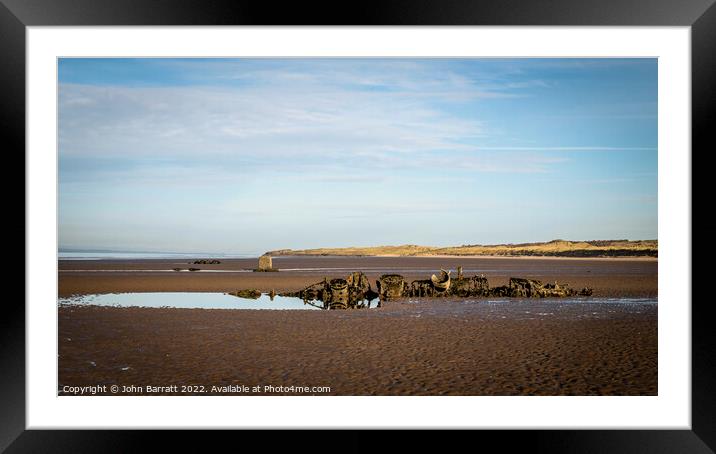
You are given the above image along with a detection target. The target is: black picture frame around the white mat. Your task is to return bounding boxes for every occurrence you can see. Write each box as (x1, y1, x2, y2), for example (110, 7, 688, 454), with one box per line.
(0, 0, 704, 453)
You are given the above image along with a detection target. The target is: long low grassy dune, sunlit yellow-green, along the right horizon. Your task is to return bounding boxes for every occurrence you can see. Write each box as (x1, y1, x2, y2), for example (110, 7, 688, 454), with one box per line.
(269, 240, 659, 257)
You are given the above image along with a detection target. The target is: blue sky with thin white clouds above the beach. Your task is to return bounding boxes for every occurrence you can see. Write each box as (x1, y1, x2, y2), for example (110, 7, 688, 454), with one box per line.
(58, 58, 658, 254)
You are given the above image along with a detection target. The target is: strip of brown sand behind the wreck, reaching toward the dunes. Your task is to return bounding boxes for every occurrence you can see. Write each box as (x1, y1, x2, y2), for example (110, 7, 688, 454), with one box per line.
(58, 257, 658, 297)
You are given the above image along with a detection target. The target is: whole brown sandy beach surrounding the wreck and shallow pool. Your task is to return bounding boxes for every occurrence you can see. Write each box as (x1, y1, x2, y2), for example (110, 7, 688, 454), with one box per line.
(58, 257, 658, 395)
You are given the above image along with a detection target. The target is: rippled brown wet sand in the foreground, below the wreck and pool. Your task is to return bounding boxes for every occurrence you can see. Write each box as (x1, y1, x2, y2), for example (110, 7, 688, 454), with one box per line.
(59, 300, 657, 395)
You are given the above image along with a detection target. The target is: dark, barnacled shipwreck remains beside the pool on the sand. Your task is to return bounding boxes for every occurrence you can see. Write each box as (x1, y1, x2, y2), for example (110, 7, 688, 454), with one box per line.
(281, 267, 592, 309)
